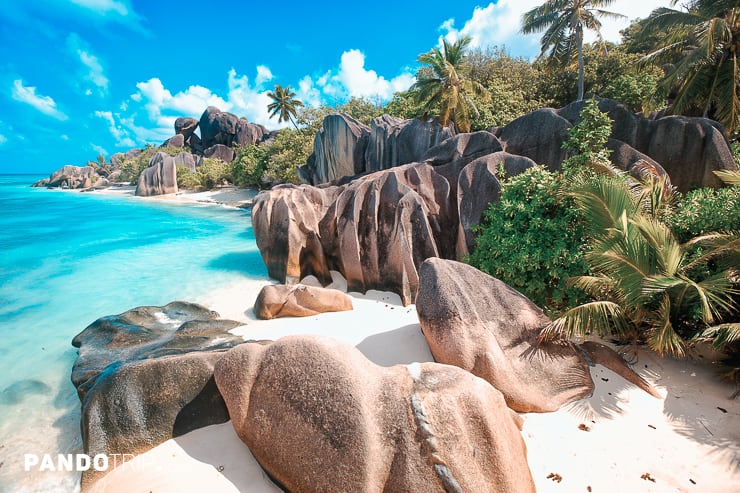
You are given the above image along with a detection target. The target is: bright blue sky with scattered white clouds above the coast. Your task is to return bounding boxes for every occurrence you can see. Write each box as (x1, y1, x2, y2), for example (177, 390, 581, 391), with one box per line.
(0, 0, 668, 173)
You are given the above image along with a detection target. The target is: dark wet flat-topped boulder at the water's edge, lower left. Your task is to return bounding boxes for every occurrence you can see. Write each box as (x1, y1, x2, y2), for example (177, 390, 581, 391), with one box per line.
(72, 302, 251, 483)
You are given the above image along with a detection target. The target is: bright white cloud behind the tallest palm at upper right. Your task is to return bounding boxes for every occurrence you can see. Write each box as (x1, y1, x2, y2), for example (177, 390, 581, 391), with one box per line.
(440, 0, 670, 58)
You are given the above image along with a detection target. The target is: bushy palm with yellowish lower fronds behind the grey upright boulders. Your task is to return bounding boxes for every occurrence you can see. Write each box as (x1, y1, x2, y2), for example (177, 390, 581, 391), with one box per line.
(411, 36, 490, 132)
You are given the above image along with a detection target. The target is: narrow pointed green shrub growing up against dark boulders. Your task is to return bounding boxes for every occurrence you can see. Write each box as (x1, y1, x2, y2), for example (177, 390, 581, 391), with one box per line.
(563, 99, 612, 173)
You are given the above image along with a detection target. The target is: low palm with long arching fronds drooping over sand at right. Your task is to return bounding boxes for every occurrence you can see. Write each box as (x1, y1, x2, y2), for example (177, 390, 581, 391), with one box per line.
(543, 174, 740, 356)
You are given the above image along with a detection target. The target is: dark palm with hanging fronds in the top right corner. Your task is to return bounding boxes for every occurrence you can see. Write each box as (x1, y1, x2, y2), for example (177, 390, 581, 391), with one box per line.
(643, 0, 740, 135)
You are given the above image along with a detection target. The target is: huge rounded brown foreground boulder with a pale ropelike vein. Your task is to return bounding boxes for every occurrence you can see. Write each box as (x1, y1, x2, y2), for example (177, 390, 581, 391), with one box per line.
(214, 336, 534, 493)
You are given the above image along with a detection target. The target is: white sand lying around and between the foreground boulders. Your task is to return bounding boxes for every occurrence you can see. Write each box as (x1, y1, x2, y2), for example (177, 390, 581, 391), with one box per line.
(87, 279, 740, 493)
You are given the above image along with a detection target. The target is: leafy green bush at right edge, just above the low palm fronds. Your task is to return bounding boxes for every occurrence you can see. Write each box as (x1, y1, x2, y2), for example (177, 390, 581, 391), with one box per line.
(671, 186, 740, 242)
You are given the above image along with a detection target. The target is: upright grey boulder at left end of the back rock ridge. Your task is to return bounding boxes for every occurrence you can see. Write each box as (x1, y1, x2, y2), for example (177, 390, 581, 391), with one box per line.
(306, 113, 370, 185)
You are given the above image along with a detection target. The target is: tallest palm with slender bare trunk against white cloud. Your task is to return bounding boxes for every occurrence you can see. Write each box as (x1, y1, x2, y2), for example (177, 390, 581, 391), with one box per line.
(521, 0, 624, 101)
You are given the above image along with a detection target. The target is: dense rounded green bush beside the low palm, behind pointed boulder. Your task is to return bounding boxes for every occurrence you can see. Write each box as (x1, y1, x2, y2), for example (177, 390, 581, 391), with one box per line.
(469, 166, 587, 312)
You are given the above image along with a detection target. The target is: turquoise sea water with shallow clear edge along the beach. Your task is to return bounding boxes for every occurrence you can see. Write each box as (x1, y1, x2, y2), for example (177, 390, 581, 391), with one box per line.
(0, 175, 267, 491)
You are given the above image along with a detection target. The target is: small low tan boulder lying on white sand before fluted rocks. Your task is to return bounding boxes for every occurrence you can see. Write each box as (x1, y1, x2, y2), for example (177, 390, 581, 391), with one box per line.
(254, 284, 352, 320)
